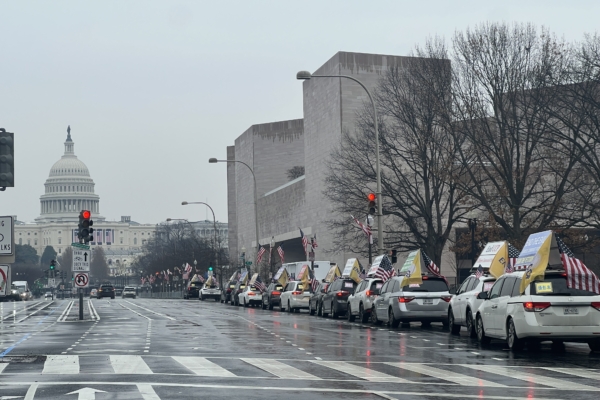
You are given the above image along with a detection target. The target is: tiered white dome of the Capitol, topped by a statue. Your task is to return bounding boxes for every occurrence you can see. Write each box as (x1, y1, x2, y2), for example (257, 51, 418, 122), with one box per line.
(35, 127, 105, 223)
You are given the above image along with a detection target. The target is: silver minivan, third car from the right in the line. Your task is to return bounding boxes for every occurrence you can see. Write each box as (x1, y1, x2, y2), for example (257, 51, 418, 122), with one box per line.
(371, 275, 452, 328)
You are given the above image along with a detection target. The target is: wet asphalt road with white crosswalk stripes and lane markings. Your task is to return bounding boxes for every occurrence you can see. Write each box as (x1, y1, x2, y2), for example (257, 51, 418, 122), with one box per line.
(0, 299, 600, 400)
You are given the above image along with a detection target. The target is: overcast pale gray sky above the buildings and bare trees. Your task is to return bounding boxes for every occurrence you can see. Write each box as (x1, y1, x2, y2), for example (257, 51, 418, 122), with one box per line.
(0, 0, 600, 223)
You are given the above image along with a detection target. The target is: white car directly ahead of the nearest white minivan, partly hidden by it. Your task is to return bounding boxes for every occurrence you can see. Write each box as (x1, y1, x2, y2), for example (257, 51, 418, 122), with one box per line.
(448, 274, 496, 337)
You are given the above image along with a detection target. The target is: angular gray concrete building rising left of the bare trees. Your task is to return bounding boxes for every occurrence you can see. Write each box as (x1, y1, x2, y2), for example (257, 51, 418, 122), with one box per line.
(227, 52, 460, 282)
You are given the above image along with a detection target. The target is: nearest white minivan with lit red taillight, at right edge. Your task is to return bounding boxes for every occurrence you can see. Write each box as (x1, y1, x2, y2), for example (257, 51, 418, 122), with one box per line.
(476, 270, 600, 351)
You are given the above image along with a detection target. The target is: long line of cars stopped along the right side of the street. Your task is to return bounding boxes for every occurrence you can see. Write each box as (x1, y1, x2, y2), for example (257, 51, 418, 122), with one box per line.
(207, 270, 600, 352)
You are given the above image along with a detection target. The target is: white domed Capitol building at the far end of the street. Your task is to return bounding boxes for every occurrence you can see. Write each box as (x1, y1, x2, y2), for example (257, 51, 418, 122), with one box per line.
(14, 128, 228, 275)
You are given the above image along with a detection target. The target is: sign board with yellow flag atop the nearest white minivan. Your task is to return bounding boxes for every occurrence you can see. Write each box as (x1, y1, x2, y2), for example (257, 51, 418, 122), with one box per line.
(515, 231, 554, 293)
